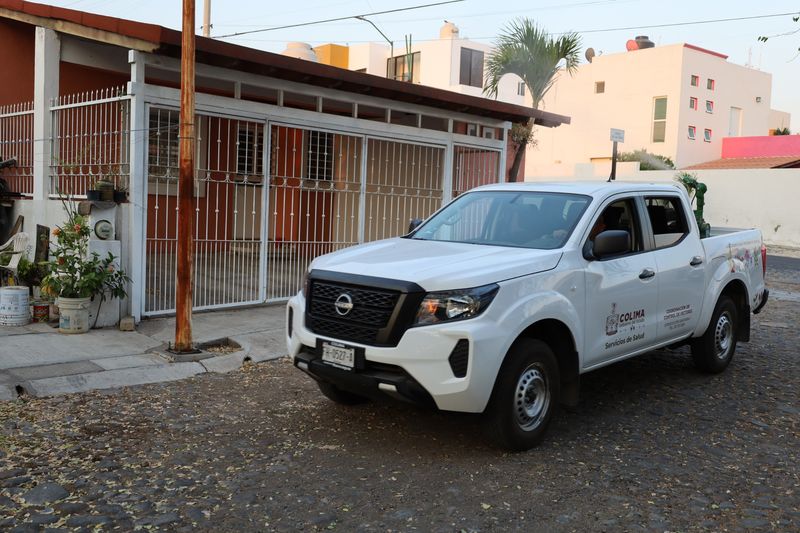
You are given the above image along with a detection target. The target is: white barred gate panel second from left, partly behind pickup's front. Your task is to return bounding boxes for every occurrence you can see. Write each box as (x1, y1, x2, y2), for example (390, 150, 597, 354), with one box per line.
(266, 125, 363, 300)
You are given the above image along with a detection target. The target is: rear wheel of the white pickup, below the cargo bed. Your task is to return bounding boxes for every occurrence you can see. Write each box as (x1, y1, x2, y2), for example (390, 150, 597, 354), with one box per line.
(691, 294, 739, 374)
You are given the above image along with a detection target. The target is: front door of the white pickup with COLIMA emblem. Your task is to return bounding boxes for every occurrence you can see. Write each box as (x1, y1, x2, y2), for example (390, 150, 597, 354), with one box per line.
(583, 197, 658, 369)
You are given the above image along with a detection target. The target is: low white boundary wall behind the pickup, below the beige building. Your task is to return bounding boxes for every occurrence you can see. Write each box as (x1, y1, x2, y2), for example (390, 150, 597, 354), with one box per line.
(526, 163, 800, 248)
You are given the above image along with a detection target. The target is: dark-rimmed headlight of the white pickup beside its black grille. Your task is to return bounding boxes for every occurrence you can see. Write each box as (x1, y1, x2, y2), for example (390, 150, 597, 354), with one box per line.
(413, 283, 500, 326)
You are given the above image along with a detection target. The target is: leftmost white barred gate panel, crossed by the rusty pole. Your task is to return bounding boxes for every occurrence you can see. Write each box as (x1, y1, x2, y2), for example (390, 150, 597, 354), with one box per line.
(144, 107, 264, 315)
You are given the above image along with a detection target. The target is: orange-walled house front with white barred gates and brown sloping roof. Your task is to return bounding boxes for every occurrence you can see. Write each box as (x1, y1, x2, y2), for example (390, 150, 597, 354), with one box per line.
(0, 0, 569, 320)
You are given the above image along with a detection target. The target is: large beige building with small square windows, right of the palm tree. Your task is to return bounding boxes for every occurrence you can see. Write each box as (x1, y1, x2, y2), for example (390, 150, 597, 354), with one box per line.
(525, 41, 789, 176)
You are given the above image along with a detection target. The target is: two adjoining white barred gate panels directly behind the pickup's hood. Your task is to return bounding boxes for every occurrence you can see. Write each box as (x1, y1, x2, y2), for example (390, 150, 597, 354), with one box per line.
(266, 125, 445, 300)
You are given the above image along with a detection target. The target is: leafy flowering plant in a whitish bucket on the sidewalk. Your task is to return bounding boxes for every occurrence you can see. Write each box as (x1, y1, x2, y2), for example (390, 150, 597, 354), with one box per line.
(42, 201, 130, 333)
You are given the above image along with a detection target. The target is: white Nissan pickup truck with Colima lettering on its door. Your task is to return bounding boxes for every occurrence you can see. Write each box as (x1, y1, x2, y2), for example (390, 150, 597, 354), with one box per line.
(286, 183, 768, 450)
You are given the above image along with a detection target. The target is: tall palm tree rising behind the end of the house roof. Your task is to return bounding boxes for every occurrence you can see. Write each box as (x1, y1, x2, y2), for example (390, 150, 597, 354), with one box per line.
(483, 18, 581, 181)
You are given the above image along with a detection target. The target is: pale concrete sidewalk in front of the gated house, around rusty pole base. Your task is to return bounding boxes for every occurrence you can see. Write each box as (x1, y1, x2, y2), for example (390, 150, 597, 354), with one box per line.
(0, 305, 286, 400)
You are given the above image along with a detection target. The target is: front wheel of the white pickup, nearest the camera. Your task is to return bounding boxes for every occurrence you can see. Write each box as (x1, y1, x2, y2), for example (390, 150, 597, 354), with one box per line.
(485, 339, 560, 451)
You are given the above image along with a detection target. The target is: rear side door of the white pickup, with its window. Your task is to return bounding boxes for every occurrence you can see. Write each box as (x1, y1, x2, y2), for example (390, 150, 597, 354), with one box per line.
(644, 194, 706, 342)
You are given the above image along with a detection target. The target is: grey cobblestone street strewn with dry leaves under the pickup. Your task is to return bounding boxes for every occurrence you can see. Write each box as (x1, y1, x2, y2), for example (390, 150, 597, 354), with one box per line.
(0, 262, 800, 532)
